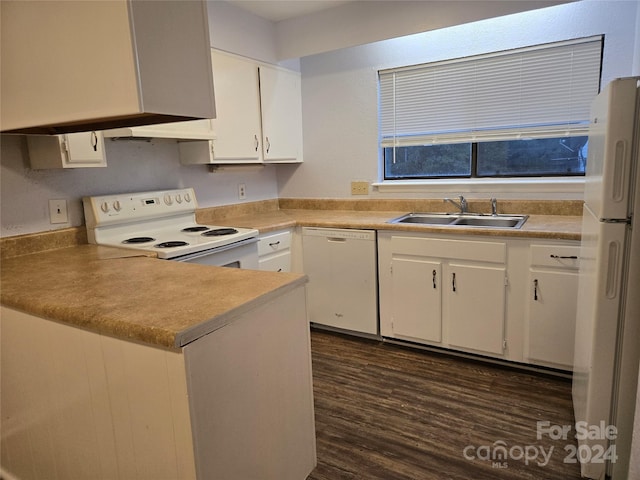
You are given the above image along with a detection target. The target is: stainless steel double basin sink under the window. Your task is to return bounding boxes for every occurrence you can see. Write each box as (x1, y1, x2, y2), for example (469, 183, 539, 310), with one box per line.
(388, 213, 529, 228)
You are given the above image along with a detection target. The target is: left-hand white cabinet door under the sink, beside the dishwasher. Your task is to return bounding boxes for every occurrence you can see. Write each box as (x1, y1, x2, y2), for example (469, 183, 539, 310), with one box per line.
(391, 258, 442, 343)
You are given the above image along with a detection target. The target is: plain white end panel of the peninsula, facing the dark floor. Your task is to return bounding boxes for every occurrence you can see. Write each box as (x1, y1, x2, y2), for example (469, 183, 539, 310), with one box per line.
(185, 288, 316, 480)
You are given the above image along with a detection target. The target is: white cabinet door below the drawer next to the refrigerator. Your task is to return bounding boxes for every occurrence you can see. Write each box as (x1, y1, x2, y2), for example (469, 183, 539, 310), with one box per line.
(528, 269, 578, 368)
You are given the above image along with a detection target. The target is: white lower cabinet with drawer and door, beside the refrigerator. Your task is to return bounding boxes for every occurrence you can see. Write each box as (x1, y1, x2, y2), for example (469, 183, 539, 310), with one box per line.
(525, 244, 580, 370)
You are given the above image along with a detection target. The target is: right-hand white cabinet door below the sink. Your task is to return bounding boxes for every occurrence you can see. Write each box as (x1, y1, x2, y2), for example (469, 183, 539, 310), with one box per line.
(444, 263, 506, 354)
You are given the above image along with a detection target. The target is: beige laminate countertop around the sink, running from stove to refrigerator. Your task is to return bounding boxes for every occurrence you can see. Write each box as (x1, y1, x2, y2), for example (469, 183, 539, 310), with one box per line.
(227, 209, 582, 240)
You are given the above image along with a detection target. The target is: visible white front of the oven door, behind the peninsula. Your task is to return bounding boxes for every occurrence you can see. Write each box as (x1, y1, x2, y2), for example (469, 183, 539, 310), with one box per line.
(171, 238, 258, 270)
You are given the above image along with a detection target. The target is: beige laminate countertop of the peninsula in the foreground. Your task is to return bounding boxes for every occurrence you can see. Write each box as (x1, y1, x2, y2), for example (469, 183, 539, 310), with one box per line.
(0, 245, 307, 349)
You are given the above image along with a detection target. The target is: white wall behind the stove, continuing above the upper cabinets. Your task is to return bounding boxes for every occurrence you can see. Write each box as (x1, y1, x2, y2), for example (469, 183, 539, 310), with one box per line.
(0, 1, 277, 237)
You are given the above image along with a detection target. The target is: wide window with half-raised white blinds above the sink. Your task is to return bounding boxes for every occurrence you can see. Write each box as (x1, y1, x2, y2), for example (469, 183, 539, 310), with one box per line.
(379, 37, 603, 180)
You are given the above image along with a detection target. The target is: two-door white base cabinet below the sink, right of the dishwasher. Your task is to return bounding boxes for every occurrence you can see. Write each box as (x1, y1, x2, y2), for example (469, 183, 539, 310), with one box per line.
(378, 231, 506, 356)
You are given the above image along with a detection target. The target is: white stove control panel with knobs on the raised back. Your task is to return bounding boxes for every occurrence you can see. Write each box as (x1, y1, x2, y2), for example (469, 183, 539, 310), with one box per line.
(82, 188, 198, 228)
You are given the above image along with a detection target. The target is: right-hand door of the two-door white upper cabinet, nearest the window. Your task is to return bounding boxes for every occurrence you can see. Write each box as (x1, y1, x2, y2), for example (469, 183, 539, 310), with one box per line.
(258, 66, 302, 163)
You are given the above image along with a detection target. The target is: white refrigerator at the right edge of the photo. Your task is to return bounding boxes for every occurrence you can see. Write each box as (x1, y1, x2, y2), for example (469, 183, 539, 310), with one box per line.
(573, 77, 640, 480)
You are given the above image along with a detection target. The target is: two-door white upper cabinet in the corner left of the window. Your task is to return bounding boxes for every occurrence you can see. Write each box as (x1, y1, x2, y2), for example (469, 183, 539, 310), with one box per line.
(180, 50, 302, 165)
